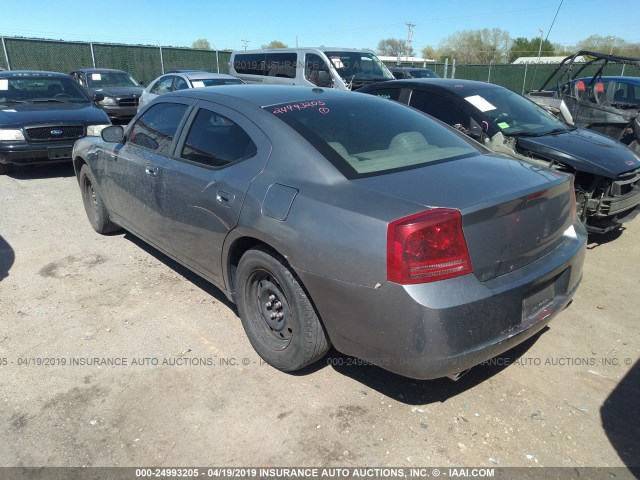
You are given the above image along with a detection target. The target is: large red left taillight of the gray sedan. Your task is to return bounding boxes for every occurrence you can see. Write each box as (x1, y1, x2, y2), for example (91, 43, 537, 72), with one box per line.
(387, 208, 472, 285)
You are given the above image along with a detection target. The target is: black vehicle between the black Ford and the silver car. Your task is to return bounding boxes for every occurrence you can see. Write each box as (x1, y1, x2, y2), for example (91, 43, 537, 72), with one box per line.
(70, 68, 143, 123)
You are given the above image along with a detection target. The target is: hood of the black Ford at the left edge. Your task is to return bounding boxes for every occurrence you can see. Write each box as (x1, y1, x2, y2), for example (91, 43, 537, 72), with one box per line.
(0, 103, 110, 128)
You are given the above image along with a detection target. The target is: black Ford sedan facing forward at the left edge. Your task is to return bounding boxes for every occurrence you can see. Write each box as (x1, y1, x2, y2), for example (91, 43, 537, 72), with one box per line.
(0, 70, 110, 174)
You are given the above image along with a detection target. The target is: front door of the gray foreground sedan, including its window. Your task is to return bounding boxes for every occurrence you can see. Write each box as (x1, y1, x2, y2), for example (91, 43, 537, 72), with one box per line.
(106, 99, 191, 243)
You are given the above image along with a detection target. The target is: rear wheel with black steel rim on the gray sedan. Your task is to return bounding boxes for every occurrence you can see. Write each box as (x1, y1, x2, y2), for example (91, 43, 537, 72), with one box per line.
(236, 248, 331, 372)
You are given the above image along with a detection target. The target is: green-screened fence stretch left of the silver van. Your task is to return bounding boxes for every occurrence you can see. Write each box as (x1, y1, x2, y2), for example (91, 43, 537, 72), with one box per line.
(0, 37, 231, 84)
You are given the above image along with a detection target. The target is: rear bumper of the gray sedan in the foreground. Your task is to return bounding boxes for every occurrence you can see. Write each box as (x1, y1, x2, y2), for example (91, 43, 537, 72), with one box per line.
(298, 222, 586, 379)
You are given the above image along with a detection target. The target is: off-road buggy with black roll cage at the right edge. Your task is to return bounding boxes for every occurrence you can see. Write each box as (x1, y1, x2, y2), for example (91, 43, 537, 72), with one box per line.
(528, 50, 640, 153)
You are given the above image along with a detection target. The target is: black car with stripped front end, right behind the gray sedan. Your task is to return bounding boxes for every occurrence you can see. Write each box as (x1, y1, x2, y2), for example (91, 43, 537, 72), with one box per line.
(359, 78, 640, 233)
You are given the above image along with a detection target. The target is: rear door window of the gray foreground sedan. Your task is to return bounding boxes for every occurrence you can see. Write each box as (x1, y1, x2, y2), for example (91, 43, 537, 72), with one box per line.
(180, 109, 257, 167)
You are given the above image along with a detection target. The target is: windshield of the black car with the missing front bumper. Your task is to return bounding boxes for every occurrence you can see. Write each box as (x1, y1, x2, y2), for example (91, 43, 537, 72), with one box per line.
(463, 87, 568, 135)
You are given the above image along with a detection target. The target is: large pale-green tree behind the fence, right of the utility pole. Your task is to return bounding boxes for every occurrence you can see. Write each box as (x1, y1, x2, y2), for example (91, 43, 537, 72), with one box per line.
(440, 28, 512, 64)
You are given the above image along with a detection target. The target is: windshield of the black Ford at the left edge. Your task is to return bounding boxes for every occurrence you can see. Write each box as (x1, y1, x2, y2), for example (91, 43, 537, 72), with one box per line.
(0, 75, 90, 104)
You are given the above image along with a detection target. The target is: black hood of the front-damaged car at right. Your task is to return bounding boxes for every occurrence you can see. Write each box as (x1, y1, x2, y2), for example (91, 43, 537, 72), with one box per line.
(518, 128, 640, 178)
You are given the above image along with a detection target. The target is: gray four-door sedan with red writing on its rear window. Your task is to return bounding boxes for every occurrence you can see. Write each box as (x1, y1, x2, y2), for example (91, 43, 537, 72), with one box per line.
(73, 86, 586, 379)
